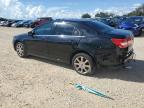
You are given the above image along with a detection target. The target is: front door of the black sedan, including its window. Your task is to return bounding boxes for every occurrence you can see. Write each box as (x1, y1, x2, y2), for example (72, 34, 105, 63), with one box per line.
(26, 22, 53, 57)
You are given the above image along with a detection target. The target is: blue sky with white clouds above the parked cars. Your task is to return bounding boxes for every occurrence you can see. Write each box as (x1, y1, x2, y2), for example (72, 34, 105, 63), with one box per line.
(0, 0, 144, 19)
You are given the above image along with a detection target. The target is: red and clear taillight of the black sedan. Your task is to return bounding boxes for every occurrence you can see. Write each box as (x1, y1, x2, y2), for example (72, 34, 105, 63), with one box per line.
(111, 38, 134, 48)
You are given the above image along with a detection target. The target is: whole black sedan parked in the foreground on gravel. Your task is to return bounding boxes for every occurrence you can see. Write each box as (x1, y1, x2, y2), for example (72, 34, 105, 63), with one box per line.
(13, 19, 134, 75)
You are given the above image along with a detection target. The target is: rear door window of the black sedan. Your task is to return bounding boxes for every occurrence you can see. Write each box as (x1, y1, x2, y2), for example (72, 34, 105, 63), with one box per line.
(55, 23, 81, 36)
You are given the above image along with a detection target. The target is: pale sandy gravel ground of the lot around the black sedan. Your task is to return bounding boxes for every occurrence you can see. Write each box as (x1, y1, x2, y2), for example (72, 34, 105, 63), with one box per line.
(0, 27, 144, 108)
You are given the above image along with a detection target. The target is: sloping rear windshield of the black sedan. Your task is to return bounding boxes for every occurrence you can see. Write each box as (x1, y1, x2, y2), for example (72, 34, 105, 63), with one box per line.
(85, 21, 114, 32)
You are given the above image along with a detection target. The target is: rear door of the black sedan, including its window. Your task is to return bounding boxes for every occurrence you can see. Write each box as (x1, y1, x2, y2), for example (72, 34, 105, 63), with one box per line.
(47, 22, 82, 62)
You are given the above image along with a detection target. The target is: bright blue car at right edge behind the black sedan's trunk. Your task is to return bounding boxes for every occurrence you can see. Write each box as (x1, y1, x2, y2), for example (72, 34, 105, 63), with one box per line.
(119, 16, 144, 36)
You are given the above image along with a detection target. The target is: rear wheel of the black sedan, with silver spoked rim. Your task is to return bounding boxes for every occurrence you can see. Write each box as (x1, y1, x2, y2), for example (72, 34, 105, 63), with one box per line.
(72, 53, 95, 75)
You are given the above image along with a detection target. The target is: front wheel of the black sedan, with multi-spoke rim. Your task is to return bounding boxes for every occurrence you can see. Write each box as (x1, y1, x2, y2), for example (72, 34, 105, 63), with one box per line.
(15, 42, 27, 58)
